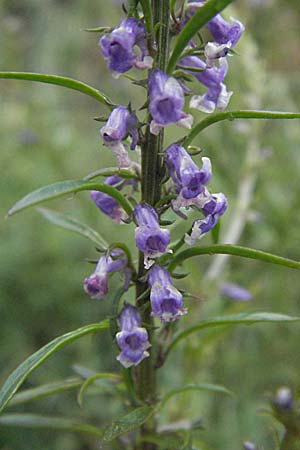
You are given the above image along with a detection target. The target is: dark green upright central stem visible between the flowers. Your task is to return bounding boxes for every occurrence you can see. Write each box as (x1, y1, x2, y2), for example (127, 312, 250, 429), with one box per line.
(135, 0, 170, 450)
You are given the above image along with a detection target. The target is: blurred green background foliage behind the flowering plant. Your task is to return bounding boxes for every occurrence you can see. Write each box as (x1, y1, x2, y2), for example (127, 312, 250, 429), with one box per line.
(0, 0, 300, 450)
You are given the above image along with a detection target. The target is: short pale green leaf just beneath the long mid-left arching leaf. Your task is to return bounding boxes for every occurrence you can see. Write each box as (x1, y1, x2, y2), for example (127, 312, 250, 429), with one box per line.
(37, 208, 109, 249)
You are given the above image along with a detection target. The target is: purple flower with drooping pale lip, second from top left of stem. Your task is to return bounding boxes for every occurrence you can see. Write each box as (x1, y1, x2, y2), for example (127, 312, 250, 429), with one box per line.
(100, 106, 138, 167)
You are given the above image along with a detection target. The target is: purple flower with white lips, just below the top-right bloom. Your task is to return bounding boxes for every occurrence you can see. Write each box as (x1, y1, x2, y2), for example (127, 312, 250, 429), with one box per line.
(180, 56, 232, 113)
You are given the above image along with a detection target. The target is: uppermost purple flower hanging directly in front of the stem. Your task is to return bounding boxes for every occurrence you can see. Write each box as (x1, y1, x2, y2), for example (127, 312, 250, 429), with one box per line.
(148, 69, 193, 135)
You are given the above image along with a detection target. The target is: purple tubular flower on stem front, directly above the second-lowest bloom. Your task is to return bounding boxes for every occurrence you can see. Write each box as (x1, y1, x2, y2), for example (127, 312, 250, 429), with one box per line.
(134, 204, 170, 268)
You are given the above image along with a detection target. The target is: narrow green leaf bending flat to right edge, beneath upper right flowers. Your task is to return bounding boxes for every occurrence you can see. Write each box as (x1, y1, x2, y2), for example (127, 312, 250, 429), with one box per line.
(182, 109, 300, 146)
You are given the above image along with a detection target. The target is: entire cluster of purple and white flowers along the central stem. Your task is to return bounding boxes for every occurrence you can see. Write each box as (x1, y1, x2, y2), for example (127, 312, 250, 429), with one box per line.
(84, 2, 244, 368)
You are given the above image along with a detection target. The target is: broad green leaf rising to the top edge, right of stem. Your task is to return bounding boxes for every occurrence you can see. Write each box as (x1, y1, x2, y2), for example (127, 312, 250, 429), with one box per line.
(167, 0, 233, 73)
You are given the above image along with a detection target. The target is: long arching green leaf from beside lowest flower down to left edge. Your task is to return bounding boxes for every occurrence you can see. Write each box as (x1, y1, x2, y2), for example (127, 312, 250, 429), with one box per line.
(0, 320, 109, 412)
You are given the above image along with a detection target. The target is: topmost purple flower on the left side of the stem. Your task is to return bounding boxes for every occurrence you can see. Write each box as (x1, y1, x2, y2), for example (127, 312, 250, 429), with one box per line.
(99, 17, 153, 73)
